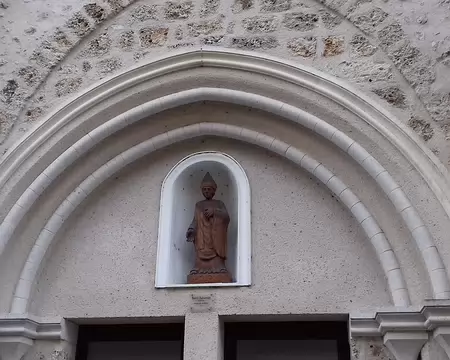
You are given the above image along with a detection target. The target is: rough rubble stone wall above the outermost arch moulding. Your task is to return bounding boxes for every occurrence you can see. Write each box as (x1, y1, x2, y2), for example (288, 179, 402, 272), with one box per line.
(0, 0, 450, 165)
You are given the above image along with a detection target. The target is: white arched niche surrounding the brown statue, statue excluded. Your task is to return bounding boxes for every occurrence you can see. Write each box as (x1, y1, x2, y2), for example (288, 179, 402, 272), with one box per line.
(155, 151, 251, 288)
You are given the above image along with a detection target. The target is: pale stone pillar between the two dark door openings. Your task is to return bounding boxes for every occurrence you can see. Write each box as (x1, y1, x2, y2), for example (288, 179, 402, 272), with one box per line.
(184, 312, 223, 360)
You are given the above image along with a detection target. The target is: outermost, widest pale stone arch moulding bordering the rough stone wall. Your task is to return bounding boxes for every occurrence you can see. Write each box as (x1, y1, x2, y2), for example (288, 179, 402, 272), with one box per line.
(0, 47, 450, 225)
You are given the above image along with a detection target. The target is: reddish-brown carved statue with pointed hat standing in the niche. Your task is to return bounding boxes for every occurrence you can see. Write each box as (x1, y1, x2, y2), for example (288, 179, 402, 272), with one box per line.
(186, 173, 232, 284)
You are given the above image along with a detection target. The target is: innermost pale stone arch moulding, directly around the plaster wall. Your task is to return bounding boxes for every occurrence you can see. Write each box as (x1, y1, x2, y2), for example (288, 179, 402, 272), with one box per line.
(11, 123, 410, 314)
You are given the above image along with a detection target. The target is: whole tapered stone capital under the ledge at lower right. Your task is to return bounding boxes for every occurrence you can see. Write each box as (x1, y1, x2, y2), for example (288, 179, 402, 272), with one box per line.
(383, 332, 428, 360)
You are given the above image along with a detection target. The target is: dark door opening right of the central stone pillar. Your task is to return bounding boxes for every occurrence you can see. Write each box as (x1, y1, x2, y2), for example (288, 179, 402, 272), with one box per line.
(224, 321, 350, 360)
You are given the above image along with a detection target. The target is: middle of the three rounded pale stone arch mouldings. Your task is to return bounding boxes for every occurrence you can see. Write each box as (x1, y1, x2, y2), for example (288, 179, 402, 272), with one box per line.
(0, 88, 450, 299)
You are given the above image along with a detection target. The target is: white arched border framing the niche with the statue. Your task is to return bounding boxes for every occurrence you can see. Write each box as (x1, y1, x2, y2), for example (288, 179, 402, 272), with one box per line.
(156, 151, 252, 288)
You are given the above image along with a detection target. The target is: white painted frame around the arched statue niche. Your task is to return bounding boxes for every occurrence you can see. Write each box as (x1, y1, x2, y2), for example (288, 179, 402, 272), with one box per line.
(155, 151, 251, 288)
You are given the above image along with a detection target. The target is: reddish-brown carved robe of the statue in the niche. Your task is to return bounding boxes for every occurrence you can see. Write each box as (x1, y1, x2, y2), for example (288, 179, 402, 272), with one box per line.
(189, 200, 230, 261)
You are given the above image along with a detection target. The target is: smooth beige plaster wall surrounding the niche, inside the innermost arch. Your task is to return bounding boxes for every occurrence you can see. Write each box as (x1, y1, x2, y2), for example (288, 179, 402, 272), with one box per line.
(31, 139, 390, 317)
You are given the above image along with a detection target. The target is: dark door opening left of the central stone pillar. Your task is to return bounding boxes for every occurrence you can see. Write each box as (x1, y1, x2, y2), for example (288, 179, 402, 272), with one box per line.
(75, 323, 184, 360)
